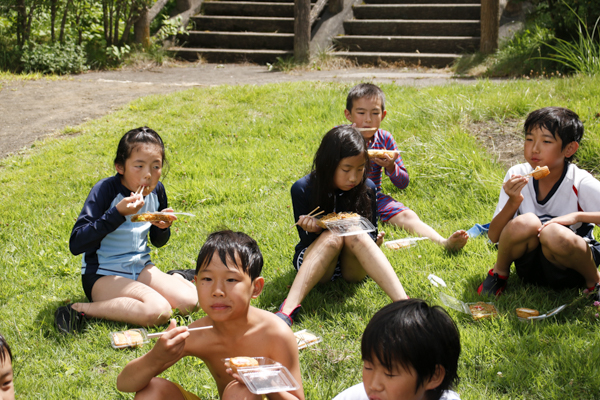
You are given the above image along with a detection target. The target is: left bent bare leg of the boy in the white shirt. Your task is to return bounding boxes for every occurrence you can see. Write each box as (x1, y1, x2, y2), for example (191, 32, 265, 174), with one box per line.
(494, 213, 545, 276)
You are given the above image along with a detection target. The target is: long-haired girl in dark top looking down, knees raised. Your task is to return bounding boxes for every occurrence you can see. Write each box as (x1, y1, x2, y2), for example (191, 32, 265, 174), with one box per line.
(276, 126, 407, 326)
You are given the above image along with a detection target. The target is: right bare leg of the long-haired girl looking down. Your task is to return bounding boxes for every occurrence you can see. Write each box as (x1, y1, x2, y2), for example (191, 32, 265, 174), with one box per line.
(340, 234, 408, 301)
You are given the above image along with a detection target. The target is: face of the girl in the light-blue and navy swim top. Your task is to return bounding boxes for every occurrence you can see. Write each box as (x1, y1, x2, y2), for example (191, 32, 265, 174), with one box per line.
(115, 143, 163, 195)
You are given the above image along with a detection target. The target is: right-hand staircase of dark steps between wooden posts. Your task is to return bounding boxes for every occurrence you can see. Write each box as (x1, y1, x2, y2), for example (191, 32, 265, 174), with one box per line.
(333, 0, 485, 67)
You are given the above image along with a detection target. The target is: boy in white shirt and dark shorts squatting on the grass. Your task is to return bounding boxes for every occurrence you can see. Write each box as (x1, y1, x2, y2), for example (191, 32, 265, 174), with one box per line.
(477, 107, 600, 297)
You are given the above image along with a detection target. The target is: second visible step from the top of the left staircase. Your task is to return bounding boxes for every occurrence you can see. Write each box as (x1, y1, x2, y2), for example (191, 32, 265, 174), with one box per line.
(192, 15, 294, 33)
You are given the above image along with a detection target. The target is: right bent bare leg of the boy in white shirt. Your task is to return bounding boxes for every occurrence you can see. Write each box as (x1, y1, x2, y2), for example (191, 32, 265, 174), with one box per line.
(540, 224, 600, 288)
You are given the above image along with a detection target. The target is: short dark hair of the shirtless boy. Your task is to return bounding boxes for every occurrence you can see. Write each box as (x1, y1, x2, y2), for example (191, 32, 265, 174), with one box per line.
(196, 230, 263, 280)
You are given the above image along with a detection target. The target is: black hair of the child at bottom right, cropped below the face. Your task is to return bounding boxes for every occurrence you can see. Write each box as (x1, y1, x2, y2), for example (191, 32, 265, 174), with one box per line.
(361, 299, 460, 400)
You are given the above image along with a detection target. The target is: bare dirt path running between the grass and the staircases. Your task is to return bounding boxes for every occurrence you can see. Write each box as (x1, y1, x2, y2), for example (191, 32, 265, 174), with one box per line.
(0, 64, 475, 158)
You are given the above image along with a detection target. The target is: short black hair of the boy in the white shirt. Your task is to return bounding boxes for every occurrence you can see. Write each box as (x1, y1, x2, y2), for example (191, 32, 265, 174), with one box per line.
(524, 107, 583, 160)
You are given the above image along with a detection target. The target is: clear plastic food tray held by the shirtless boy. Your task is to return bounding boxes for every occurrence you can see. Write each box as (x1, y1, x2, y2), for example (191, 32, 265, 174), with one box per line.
(224, 357, 299, 394)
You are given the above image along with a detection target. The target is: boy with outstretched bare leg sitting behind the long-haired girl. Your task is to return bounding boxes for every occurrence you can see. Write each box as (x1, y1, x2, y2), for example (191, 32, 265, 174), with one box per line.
(344, 83, 469, 250)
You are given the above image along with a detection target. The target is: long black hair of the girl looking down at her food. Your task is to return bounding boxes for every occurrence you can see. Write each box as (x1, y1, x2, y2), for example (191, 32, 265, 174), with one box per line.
(310, 125, 374, 218)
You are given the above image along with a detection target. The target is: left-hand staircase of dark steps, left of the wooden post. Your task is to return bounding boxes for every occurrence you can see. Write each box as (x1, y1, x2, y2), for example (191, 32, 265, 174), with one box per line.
(171, 0, 302, 64)
